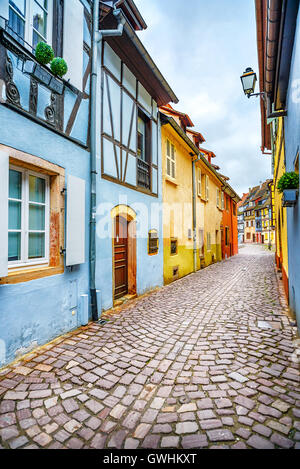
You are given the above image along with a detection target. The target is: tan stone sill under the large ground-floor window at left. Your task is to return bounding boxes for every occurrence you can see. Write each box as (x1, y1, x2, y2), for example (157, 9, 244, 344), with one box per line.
(0, 266, 64, 285)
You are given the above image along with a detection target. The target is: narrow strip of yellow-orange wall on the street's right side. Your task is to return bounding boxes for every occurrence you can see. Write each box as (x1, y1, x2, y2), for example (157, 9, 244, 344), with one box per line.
(274, 117, 288, 276)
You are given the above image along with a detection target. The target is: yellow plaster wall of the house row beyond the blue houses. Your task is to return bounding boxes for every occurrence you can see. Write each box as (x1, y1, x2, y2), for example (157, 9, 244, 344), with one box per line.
(162, 125, 222, 284)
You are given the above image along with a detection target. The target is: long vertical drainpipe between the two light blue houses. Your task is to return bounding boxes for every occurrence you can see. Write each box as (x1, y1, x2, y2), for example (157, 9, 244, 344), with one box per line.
(89, 0, 125, 321)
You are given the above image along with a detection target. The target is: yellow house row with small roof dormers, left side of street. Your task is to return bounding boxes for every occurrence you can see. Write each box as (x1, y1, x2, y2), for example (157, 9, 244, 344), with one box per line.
(161, 106, 224, 284)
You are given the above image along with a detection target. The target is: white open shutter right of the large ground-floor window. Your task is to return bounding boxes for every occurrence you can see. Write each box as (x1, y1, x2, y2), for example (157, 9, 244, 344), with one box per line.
(66, 176, 86, 266)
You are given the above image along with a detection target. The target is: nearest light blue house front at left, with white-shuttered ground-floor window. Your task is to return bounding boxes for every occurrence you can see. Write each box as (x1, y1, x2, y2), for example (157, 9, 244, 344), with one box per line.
(0, 0, 92, 366)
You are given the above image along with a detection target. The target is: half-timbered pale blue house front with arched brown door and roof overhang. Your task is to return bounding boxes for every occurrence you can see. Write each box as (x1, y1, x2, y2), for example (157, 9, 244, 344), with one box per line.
(96, 1, 177, 309)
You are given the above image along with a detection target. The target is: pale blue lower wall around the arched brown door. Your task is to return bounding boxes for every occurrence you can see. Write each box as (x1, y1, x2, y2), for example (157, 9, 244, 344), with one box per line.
(96, 119, 163, 310)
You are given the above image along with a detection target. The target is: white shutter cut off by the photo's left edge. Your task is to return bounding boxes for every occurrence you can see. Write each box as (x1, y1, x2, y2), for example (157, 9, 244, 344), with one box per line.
(0, 151, 9, 277)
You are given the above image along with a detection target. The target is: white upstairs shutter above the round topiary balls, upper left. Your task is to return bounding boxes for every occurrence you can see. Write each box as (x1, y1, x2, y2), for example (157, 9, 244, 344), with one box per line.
(63, 0, 84, 91)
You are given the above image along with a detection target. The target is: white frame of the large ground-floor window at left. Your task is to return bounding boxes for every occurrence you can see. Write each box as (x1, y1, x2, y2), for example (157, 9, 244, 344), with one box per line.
(8, 165, 50, 270)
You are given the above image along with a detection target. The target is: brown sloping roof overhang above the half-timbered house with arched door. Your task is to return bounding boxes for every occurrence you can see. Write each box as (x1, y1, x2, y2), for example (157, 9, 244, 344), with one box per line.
(100, 12, 178, 106)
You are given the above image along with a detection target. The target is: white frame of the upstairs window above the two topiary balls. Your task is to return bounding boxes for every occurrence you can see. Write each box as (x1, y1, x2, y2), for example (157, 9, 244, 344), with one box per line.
(9, 0, 53, 47)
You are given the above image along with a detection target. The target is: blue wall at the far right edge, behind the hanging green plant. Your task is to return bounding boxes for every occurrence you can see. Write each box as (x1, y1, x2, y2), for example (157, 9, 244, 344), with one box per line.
(285, 5, 300, 331)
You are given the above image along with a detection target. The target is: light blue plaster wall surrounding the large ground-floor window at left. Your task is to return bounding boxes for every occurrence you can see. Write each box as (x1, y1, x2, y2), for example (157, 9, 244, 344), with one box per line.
(0, 105, 90, 366)
